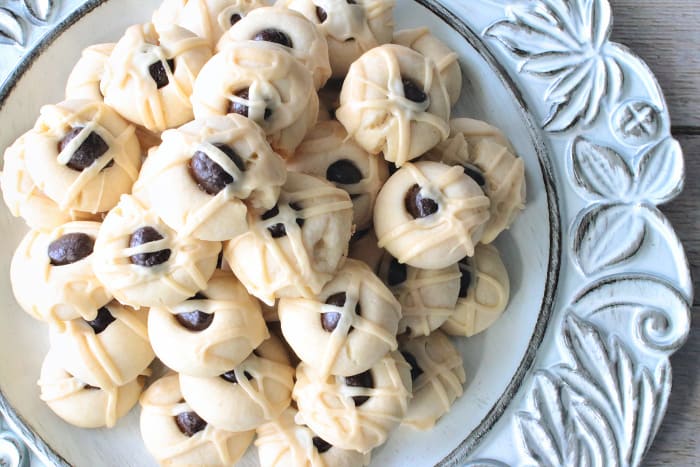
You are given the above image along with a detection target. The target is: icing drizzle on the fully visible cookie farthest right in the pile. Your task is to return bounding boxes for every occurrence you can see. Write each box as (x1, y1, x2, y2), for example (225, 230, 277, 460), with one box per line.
(378, 163, 489, 263)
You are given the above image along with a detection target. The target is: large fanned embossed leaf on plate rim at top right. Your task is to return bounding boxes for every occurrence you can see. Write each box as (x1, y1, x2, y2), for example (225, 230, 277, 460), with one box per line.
(486, 0, 623, 132)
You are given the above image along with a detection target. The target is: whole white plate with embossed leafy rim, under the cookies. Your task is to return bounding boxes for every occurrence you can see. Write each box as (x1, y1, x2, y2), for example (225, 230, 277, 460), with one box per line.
(0, 0, 692, 466)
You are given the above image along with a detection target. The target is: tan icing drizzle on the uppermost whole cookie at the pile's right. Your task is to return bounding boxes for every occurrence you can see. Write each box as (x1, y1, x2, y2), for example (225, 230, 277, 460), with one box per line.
(344, 47, 450, 167)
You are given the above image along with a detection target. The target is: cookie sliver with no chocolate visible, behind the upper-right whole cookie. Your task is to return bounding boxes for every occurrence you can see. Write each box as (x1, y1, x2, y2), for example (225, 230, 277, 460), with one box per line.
(393, 28, 462, 105)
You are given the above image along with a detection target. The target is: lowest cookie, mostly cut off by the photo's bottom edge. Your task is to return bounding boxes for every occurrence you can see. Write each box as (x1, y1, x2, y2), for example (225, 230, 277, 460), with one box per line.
(255, 407, 370, 467)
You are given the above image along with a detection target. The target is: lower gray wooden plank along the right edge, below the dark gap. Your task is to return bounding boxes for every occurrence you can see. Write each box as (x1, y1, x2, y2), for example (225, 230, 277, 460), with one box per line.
(645, 133, 700, 467)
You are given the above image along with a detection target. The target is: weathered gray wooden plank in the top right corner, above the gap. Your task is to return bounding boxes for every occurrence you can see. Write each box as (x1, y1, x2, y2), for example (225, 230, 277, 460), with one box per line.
(610, 0, 700, 127)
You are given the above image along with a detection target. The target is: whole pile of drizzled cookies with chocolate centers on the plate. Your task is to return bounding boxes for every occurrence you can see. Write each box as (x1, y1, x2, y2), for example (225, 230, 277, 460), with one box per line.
(1, 0, 525, 466)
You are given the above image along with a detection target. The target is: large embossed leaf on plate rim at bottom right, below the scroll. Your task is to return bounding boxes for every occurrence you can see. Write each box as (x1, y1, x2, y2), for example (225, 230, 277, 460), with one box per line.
(518, 313, 671, 467)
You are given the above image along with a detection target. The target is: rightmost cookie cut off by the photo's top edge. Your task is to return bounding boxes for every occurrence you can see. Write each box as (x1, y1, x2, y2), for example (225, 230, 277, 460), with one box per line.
(276, 0, 396, 79)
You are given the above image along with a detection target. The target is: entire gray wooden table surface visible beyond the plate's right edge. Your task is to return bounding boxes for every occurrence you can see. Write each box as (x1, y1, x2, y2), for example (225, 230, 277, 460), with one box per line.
(610, 0, 700, 466)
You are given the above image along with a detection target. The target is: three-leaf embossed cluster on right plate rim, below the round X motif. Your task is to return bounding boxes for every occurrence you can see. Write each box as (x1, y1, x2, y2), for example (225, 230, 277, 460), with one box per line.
(571, 137, 683, 275)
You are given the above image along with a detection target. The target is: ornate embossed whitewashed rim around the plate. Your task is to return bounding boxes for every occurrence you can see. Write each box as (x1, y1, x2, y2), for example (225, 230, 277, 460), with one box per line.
(0, 0, 693, 467)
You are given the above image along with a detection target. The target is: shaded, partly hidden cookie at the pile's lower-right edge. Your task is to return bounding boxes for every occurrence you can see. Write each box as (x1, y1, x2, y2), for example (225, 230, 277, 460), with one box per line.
(400, 331, 466, 430)
